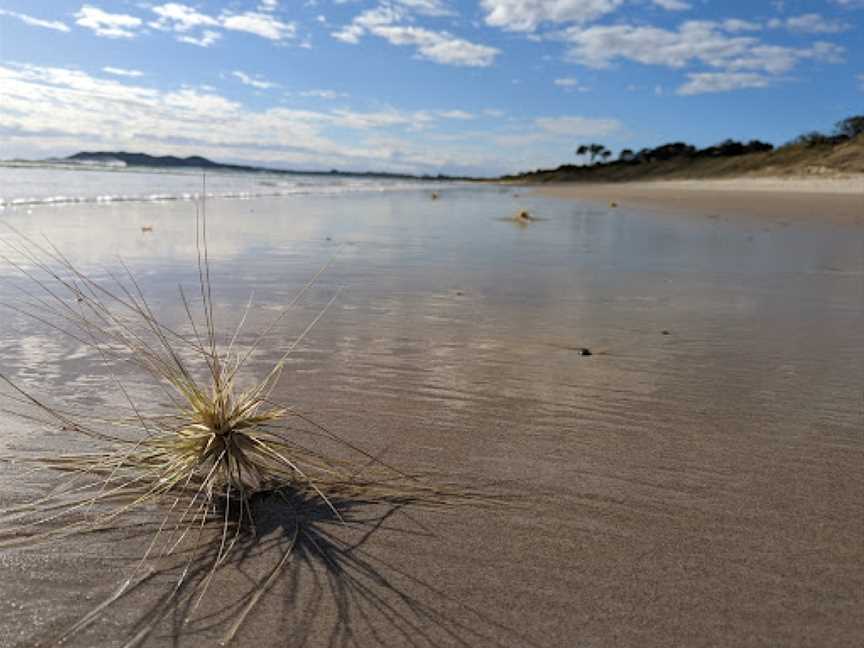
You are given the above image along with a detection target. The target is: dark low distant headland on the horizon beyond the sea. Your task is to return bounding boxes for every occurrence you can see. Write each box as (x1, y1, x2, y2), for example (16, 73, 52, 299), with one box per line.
(65, 151, 472, 180)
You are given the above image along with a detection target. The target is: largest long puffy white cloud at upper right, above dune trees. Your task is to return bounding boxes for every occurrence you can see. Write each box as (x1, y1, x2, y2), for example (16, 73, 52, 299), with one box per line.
(564, 21, 843, 74)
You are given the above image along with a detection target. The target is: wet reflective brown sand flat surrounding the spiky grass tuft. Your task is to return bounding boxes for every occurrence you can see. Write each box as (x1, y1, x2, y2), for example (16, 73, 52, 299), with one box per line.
(0, 189, 864, 648)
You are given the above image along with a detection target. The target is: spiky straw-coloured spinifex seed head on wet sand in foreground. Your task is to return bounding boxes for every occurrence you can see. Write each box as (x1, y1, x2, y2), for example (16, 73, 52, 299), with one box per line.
(0, 197, 481, 643)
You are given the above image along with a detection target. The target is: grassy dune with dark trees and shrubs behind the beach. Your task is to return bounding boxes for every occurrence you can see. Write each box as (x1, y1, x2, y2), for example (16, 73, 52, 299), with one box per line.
(502, 115, 864, 182)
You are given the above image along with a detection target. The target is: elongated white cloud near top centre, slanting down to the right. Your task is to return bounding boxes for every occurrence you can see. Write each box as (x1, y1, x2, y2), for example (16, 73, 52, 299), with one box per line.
(331, 5, 500, 67)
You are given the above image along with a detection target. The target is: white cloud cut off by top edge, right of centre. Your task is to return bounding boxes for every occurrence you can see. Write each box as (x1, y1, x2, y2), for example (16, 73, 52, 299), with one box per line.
(480, 0, 624, 31)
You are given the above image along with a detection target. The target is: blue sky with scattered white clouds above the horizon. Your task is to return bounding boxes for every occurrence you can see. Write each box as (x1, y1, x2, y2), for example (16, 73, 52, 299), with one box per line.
(0, 0, 864, 175)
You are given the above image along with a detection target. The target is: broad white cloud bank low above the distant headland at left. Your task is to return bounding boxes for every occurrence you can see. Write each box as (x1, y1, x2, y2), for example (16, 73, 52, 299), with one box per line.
(0, 64, 512, 173)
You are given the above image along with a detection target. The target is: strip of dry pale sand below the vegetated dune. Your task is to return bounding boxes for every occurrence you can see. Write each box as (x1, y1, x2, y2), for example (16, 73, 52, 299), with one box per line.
(529, 176, 864, 225)
